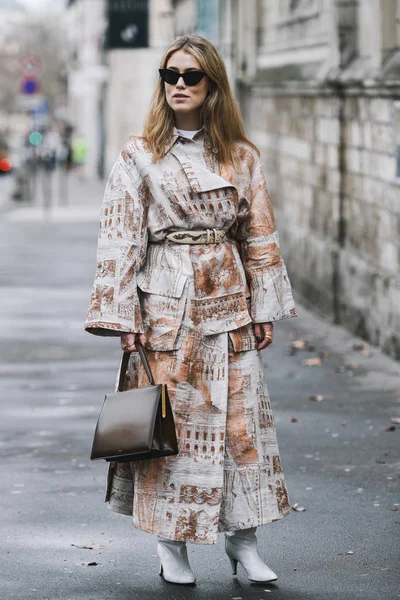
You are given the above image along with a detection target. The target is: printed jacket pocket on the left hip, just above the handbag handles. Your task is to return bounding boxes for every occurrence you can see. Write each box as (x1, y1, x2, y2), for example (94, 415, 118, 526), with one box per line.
(138, 279, 187, 351)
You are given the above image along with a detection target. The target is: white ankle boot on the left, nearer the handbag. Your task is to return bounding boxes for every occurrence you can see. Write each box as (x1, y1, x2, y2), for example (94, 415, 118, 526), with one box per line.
(157, 538, 196, 585)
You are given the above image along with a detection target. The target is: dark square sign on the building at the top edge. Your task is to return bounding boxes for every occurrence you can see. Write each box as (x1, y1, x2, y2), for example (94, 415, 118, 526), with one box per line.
(107, 0, 149, 49)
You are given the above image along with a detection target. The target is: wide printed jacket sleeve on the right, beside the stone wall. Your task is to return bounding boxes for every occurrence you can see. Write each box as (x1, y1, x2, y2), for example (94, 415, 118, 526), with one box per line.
(235, 152, 297, 323)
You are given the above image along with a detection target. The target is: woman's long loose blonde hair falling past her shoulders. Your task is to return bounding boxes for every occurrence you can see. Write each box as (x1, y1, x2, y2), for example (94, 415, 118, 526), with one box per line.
(143, 35, 260, 167)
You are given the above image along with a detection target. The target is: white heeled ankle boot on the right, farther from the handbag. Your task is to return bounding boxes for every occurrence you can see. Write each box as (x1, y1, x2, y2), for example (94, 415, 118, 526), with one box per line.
(225, 527, 278, 583)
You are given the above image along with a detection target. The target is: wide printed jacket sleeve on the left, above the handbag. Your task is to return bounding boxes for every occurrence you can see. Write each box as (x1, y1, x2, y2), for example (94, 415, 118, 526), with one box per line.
(85, 146, 148, 336)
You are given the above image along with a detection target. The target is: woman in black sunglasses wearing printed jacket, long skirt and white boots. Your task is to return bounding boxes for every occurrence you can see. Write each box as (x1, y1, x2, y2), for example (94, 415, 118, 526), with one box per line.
(86, 36, 296, 584)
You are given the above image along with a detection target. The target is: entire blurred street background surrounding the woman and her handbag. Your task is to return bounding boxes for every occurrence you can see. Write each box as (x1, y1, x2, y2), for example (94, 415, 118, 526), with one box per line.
(0, 0, 400, 600)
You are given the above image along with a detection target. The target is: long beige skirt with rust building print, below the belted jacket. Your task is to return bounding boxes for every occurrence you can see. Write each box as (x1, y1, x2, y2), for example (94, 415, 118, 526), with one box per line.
(106, 280, 290, 544)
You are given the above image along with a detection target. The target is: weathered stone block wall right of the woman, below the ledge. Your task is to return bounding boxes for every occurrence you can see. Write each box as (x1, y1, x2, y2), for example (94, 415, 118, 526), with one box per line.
(241, 85, 400, 359)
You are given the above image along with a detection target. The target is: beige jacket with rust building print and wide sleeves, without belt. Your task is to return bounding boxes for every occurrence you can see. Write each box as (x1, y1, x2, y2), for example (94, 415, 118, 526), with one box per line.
(86, 130, 296, 350)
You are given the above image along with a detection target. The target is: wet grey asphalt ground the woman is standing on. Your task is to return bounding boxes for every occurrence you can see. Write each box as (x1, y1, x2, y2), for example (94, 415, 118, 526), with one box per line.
(0, 190, 400, 600)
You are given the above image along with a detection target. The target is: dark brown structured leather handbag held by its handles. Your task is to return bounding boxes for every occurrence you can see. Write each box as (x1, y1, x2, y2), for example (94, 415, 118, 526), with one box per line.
(90, 342, 178, 462)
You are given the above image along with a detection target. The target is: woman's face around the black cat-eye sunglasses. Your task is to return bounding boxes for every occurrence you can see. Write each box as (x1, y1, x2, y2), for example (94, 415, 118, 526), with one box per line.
(164, 50, 209, 114)
